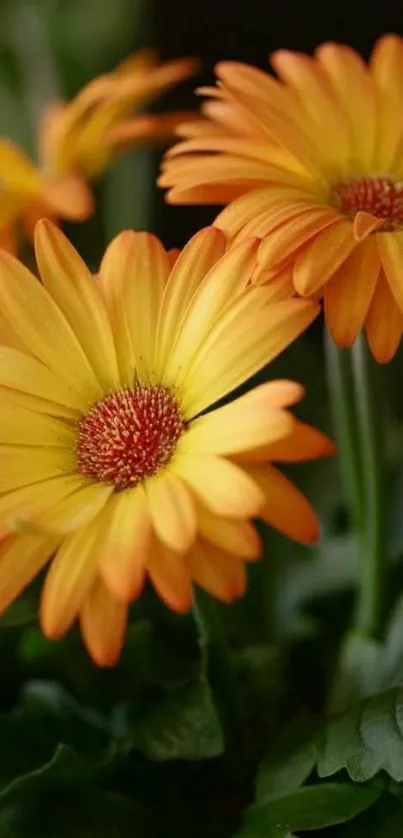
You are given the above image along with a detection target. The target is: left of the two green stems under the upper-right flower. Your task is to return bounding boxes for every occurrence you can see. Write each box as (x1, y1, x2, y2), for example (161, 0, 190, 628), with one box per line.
(325, 329, 365, 540)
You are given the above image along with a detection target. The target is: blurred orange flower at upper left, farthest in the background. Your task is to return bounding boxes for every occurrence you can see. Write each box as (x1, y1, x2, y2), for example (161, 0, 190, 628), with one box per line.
(0, 50, 196, 251)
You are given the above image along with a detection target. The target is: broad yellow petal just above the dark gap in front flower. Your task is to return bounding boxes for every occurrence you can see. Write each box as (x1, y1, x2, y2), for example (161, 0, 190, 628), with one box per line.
(180, 296, 319, 418)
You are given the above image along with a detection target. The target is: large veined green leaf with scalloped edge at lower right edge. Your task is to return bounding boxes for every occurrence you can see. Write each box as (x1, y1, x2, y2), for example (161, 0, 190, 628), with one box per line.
(317, 689, 403, 782)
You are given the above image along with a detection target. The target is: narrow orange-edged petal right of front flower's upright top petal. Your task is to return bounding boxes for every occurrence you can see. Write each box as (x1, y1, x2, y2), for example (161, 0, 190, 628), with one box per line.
(156, 227, 225, 372)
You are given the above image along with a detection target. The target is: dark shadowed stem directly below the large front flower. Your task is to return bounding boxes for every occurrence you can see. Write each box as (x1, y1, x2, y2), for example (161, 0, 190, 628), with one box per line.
(193, 590, 245, 771)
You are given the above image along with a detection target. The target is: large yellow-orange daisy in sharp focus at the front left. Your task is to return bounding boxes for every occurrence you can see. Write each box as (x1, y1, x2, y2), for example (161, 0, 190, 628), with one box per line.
(0, 221, 332, 665)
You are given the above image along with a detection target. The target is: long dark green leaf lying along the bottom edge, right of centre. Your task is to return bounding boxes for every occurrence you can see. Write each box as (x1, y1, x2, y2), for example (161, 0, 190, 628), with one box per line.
(237, 783, 379, 838)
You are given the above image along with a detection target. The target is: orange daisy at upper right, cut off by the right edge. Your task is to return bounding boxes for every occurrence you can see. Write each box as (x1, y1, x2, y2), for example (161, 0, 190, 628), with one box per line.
(160, 35, 403, 363)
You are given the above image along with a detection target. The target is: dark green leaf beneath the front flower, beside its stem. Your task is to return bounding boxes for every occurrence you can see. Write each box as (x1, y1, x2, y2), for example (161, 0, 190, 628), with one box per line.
(132, 678, 224, 761)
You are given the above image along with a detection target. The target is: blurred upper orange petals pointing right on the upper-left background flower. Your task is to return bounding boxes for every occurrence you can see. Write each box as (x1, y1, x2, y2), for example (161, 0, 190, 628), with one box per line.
(40, 50, 196, 179)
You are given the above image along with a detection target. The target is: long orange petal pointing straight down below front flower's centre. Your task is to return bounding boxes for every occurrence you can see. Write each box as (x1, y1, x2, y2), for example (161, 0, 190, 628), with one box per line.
(100, 486, 151, 602)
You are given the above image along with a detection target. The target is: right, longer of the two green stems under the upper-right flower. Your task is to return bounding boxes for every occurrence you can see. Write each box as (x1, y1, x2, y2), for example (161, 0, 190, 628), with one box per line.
(352, 335, 387, 637)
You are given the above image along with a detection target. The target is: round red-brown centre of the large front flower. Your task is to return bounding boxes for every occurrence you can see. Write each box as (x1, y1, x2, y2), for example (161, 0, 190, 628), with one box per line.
(76, 386, 185, 492)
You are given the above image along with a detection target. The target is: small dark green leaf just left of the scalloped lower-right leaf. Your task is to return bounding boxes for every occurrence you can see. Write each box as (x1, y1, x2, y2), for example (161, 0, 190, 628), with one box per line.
(256, 719, 317, 801)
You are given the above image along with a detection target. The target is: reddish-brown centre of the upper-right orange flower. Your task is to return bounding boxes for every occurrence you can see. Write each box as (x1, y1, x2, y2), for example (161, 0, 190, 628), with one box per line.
(332, 177, 403, 231)
